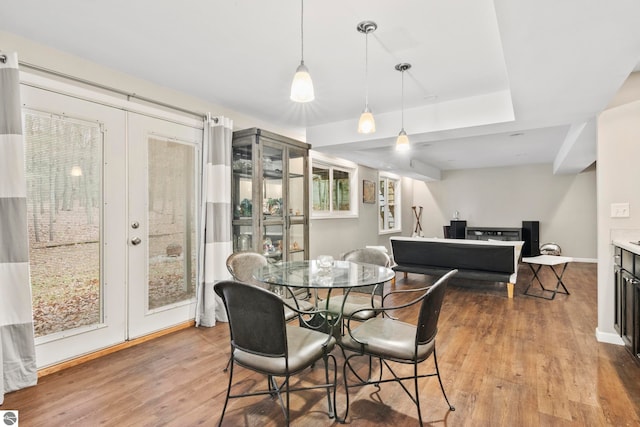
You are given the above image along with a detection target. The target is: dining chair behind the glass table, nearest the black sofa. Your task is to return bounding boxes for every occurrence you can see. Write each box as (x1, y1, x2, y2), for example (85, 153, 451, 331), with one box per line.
(327, 248, 391, 321)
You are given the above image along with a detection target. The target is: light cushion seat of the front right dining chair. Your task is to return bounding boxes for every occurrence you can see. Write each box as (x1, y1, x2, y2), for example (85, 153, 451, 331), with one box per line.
(340, 317, 435, 361)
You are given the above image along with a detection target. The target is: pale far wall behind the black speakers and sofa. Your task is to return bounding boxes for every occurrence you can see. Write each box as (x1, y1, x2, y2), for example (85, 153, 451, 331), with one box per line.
(413, 164, 596, 260)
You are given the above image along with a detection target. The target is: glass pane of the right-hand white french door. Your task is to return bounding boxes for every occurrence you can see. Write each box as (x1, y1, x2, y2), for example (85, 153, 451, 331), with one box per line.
(148, 137, 196, 310)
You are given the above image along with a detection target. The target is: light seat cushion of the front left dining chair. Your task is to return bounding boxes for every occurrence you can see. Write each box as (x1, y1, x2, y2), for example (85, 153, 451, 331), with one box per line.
(233, 325, 336, 375)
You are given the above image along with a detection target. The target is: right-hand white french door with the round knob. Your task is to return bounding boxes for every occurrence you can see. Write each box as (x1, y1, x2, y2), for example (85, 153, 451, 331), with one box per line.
(128, 113, 202, 338)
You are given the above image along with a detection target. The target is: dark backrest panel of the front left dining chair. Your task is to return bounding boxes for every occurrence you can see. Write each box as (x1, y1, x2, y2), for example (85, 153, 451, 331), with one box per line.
(214, 280, 287, 357)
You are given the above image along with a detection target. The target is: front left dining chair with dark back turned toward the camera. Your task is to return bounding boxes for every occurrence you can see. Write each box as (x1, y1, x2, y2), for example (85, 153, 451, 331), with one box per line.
(214, 280, 337, 425)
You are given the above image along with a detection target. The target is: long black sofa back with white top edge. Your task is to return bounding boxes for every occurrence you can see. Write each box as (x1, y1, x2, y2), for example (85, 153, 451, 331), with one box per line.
(390, 237, 516, 274)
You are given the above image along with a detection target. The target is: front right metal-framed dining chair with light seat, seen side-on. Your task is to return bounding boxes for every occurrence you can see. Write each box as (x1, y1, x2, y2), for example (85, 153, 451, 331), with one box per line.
(339, 270, 457, 426)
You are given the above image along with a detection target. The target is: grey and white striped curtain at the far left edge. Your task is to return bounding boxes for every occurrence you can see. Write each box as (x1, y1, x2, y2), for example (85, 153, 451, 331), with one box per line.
(0, 52, 38, 404)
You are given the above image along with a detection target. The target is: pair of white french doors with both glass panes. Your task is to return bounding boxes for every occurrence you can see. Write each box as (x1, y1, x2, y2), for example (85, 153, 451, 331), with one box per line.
(21, 77, 202, 367)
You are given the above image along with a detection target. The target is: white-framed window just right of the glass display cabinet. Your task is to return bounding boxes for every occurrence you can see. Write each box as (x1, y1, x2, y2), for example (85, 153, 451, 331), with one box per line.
(311, 152, 358, 218)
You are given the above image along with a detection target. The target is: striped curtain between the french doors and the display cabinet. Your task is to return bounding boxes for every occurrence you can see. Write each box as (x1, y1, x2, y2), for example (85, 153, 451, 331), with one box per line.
(196, 117, 233, 326)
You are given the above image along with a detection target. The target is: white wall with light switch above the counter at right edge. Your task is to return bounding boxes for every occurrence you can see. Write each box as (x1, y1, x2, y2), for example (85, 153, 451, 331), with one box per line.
(596, 73, 640, 344)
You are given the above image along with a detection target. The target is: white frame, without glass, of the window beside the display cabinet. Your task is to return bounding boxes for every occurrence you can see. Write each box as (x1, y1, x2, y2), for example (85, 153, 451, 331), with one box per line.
(309, 150, 359, 219)
